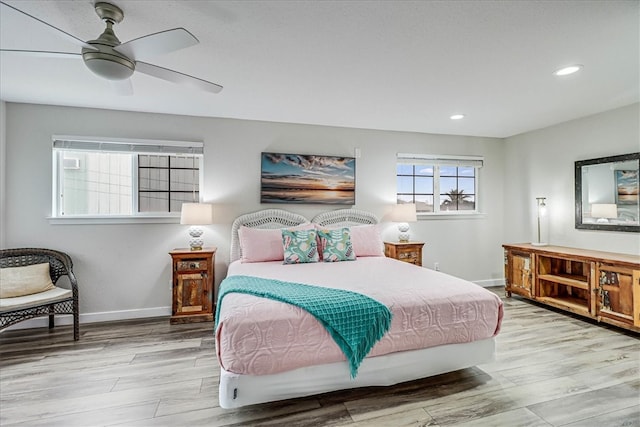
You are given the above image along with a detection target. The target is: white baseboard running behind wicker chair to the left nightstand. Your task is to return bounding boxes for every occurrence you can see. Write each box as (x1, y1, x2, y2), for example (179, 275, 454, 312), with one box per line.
(1, 307, 171, 331)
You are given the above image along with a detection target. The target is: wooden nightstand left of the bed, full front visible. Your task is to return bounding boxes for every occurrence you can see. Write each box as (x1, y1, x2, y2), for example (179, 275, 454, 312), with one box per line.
(169, 248, 217, 324)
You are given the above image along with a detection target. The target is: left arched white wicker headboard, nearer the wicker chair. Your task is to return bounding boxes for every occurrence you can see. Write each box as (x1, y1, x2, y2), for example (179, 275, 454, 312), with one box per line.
(230, 209, 309, 262)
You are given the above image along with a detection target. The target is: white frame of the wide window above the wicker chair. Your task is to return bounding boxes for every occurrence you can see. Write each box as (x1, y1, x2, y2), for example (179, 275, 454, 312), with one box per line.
(49, 135, 204, 224)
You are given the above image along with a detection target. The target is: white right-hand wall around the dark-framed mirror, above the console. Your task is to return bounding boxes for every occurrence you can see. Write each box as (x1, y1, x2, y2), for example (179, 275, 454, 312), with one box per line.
(504, 104, 640, 255)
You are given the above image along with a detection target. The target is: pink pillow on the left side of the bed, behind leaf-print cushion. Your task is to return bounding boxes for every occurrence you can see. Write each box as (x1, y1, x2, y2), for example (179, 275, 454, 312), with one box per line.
(238, 224, 313, 262)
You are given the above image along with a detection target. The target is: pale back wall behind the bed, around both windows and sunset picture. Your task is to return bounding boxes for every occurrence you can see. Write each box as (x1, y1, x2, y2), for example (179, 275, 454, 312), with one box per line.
(1, 103, 506, 321)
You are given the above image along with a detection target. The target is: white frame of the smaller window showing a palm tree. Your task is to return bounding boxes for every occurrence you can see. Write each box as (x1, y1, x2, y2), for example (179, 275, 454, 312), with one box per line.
(396, 153, 484, 218)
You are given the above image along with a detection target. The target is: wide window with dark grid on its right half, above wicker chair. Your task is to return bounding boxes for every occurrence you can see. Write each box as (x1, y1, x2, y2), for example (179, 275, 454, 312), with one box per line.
(53, 136, 203, 217)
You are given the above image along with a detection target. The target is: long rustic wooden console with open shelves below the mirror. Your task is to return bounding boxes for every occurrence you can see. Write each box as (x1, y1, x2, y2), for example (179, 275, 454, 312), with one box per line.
(502, 243, 640, 332)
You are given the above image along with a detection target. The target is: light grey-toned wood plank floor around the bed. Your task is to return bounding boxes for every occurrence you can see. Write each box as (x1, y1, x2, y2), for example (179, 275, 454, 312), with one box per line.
(0, 288, 640, 427)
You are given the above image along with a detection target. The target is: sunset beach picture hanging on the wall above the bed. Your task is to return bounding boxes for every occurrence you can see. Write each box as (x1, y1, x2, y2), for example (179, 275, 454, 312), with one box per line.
(260, 153, 356, 205)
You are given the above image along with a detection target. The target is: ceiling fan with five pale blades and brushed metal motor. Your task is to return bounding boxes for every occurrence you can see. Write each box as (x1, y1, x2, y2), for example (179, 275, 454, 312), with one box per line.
(0, 1, 222, 94)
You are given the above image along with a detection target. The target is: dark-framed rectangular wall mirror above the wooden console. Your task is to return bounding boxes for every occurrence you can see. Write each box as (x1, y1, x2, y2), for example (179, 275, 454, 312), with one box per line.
(575, 153, 640, 233)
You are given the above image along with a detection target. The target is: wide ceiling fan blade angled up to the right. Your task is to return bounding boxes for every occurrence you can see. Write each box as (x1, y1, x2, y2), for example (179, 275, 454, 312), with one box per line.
(115, 28, 199, 59)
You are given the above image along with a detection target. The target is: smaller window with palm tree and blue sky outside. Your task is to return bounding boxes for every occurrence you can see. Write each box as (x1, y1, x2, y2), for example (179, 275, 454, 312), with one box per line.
(396, 153, 483, 214)
